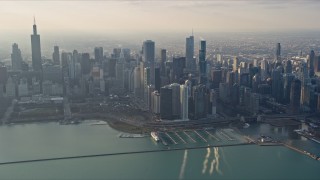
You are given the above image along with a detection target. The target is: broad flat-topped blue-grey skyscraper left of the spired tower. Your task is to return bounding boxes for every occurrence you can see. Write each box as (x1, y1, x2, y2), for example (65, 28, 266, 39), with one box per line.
(142, 40, 155, 84)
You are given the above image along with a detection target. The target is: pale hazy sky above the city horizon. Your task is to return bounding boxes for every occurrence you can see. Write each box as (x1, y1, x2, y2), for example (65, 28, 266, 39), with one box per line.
(0, 0, 320, 34)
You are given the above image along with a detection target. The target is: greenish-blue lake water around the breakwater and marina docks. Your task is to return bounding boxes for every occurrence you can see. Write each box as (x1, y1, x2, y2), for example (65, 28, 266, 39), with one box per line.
(0, 123, 320, 179)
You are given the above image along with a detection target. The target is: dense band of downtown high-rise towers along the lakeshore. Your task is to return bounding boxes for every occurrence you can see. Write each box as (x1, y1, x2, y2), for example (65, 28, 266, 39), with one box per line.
(0, 21, 320, 120)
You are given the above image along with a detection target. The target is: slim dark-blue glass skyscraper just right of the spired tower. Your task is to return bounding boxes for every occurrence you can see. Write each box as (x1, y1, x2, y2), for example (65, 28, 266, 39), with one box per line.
(199, 40, 207, 85)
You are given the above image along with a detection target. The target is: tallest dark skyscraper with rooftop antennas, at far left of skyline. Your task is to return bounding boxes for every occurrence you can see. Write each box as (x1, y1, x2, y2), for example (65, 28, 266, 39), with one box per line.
(31, 19, 42, 72)
